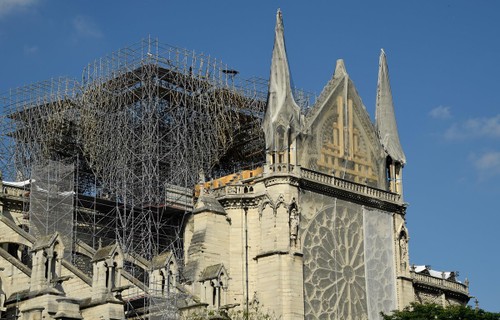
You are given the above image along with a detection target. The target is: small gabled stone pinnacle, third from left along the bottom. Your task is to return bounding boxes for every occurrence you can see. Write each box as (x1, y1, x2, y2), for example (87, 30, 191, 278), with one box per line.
(149, 251, 179, 297)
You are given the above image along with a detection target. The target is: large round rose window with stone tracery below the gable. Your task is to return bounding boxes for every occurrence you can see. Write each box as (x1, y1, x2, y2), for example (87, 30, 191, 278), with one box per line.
(304, 206, 367, 319)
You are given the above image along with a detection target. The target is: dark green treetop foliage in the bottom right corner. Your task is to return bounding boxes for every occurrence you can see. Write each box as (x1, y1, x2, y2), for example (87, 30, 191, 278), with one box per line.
(381, 303, 500, 320)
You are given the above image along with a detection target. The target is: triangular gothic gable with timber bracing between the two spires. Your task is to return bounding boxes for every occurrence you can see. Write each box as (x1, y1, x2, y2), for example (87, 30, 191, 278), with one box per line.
(300, 61, 386, 189)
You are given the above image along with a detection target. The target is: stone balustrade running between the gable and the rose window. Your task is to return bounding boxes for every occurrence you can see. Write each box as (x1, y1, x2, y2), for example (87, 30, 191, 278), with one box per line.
(300, 168, 401, 202)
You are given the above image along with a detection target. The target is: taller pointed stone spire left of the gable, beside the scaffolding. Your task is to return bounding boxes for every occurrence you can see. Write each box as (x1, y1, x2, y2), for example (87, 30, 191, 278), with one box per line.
(262, 9, 300, 153)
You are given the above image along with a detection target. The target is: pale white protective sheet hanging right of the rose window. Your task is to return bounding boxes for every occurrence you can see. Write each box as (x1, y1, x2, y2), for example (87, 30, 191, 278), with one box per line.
(363, 208, 397, 320)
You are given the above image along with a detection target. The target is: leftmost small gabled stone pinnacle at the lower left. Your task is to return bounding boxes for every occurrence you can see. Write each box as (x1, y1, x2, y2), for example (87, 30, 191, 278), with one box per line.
(30, 232, 64, 292)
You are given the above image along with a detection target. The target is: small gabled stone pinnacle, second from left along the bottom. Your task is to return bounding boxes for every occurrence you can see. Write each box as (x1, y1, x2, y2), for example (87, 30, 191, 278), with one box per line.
(92, 243, 124, 301)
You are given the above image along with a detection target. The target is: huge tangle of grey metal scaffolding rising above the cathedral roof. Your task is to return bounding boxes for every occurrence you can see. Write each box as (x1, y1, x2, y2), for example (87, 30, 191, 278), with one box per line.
(0, 39, 307, 317)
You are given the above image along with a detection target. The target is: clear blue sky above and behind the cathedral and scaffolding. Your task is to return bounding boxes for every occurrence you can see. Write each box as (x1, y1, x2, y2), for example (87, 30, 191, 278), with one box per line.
(0, 0, 500, 311)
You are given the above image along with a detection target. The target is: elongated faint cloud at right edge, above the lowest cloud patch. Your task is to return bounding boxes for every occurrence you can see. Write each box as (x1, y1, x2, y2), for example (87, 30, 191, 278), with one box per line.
(444, 114, 500, 140)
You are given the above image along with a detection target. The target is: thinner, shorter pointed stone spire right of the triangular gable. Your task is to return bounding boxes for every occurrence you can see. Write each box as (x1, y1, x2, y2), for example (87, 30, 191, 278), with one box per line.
(375, 49, 406, 166)
